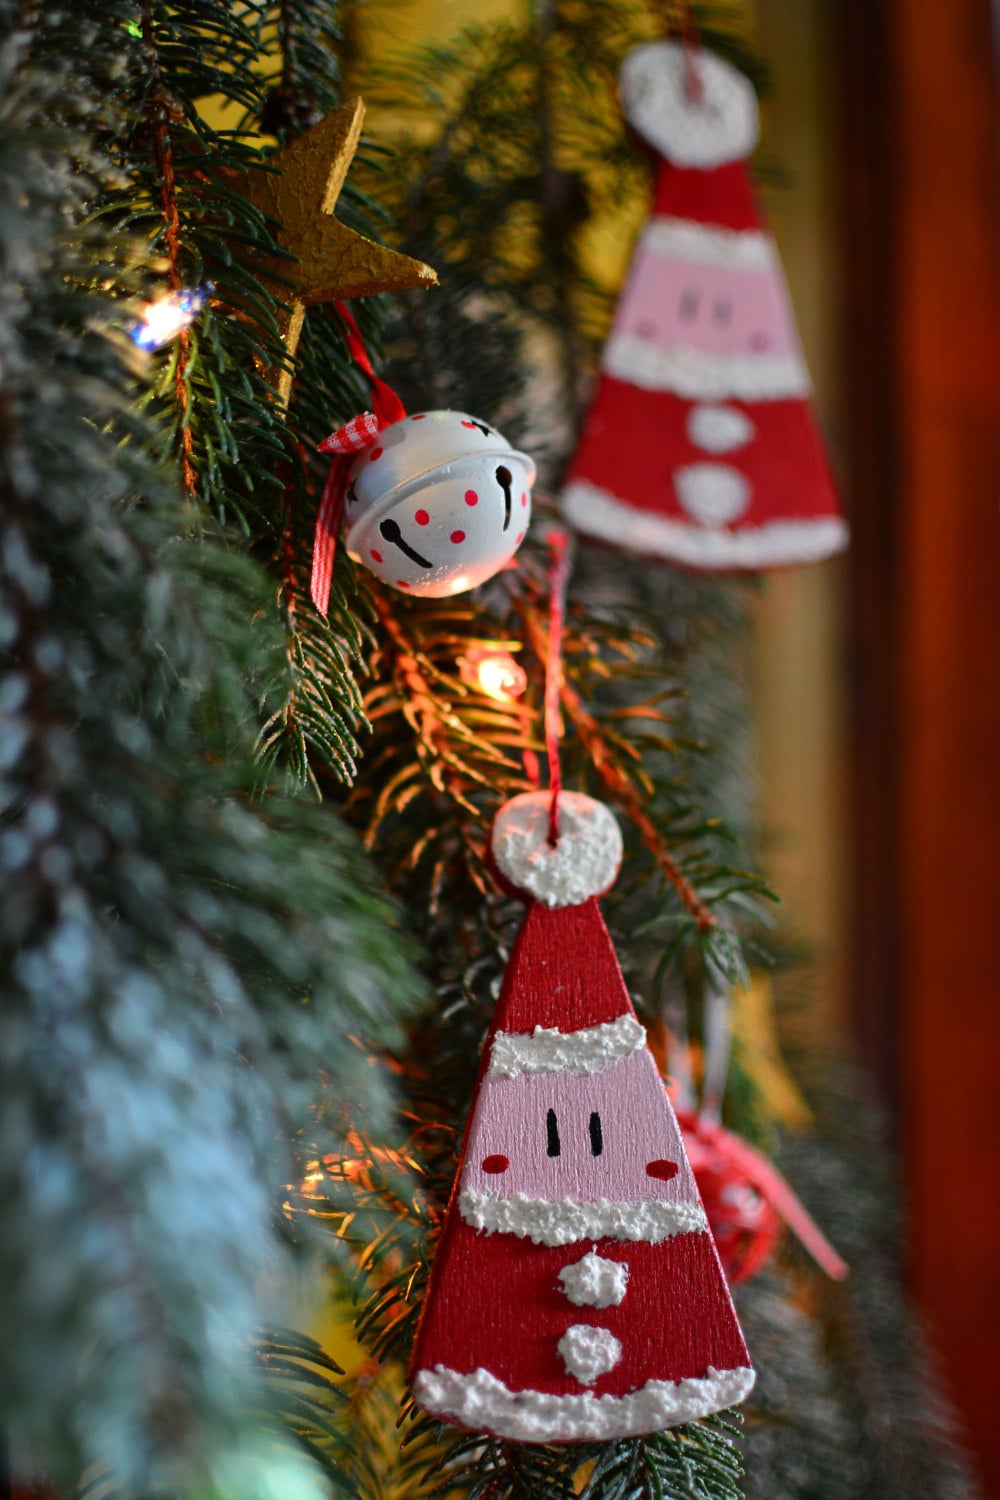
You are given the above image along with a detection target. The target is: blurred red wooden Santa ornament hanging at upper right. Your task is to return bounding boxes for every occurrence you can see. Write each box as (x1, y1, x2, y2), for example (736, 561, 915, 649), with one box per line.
(564, 42, 847, 570)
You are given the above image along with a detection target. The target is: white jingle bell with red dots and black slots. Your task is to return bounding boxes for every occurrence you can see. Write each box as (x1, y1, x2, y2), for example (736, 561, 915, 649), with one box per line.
(343, 411, 535, 599)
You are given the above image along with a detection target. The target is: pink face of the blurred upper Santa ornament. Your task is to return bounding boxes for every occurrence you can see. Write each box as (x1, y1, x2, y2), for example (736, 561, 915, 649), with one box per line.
(615, 248, 799, 354)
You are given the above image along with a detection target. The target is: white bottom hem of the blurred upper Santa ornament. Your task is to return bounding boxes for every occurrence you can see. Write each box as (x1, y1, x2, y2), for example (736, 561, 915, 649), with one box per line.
(562, 479, 849, 569)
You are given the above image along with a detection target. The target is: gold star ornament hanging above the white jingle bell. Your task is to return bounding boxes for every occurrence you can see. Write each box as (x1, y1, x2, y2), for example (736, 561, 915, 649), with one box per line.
(226, 99, 438, 407)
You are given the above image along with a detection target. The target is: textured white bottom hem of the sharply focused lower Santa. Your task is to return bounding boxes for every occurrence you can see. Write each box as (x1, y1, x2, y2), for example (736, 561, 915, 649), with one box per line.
(414, 1365, 754, 1443)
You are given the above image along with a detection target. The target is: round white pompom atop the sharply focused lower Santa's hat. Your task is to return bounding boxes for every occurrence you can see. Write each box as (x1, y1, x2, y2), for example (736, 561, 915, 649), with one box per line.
(490, 792, 622, 906)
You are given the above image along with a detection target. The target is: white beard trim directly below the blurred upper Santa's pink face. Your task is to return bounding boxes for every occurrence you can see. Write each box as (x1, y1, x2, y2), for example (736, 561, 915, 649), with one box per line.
(601, 333, 813, 401)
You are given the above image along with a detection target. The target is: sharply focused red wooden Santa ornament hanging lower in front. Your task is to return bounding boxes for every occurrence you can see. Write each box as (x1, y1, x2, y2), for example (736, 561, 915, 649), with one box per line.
(411, 792, 754, 1443)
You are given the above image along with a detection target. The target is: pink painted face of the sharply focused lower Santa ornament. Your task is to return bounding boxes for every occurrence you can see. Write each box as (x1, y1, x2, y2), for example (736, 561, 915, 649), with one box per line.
(462, 1049, 697, 1203)
